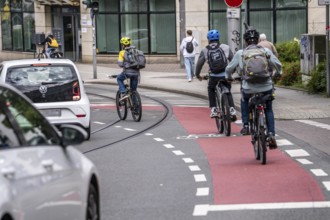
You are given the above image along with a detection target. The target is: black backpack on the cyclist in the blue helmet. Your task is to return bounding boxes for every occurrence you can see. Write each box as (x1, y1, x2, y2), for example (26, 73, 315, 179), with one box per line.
(206, 44, 228, 73)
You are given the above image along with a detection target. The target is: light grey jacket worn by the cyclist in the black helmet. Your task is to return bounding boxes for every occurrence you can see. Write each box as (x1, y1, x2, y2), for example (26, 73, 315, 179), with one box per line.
(226, 44, 282, 94)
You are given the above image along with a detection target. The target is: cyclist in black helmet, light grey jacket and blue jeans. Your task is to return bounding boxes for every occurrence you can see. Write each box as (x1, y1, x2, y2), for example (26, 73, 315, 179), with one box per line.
(226, 26, 282, 149)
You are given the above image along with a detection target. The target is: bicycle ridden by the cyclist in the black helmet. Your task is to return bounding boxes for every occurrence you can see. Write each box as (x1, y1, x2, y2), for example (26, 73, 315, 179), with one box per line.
(249, 93, 274, 164)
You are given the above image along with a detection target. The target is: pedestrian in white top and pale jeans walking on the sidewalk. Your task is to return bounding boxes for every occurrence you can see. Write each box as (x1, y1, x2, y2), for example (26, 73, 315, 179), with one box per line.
(180, 30, 198, 82)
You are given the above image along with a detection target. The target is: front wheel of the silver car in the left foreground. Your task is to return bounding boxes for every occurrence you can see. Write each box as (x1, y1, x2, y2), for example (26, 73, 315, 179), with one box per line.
(86, 184, 100, 220)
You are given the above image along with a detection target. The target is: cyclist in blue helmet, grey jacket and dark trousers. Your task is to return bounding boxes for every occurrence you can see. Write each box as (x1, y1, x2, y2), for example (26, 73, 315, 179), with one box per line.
(196, 30, 236, 121)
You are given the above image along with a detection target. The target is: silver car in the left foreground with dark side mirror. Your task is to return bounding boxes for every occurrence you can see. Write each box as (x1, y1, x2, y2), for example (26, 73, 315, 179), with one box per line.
(0, 83, 100, 220)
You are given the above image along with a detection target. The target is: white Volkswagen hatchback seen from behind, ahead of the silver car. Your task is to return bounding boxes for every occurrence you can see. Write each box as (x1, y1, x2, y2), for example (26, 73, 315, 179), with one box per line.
(0, 59, 91, 139)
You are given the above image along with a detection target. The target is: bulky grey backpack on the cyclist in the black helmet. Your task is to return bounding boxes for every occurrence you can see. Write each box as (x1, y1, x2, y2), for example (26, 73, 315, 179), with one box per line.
(242, 45, 271, 83)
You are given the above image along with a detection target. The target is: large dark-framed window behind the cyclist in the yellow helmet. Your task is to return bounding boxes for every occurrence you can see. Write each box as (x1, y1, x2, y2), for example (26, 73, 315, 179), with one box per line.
(96, 0, 176, 54)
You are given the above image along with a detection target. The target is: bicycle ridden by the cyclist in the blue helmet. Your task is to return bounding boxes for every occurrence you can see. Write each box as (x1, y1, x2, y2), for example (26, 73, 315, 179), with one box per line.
(204, 76, 231, 136)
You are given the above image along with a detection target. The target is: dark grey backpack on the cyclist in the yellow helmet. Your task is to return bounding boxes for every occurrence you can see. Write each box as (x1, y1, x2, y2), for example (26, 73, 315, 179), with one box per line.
(124, 48, 146, 69)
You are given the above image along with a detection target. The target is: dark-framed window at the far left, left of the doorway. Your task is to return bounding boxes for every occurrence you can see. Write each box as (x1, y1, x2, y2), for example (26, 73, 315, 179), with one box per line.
(0, 0, 35, 51)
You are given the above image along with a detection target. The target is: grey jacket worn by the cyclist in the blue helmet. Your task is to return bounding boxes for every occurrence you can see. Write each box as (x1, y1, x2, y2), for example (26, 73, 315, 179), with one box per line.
(196, 42, 233, 77)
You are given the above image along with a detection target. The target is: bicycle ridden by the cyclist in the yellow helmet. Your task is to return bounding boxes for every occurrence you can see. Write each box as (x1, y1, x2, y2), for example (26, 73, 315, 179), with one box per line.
(108, 75, 142, 122)
